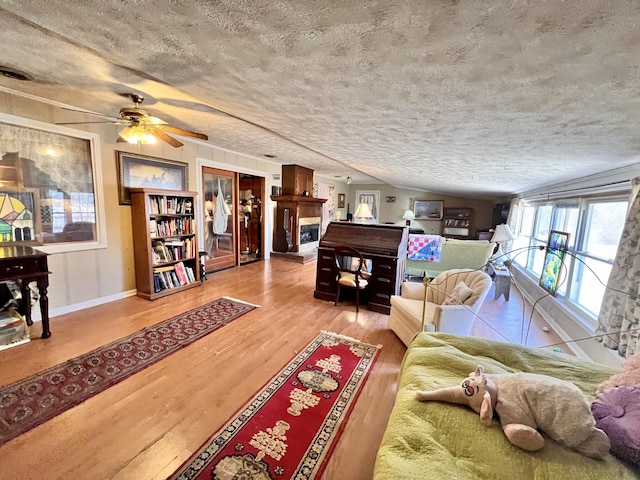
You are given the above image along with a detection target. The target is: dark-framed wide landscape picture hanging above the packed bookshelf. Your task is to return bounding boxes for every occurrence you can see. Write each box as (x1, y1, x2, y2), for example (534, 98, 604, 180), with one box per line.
(116, 152, 189, 205)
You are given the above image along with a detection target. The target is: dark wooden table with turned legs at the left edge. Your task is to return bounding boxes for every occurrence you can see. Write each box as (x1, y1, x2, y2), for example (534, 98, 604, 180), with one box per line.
(0, 245, 51, 338)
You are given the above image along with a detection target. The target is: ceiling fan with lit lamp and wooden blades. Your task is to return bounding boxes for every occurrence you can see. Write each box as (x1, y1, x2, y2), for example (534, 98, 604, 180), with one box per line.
(57, 93, 209, 147)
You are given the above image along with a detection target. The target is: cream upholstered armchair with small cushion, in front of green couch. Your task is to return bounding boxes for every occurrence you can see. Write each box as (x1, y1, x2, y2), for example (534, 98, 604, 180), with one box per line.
(389, 269, 491, 346)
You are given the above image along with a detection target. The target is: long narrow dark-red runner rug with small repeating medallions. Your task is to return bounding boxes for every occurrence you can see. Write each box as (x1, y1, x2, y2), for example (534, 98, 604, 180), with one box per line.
(0, 297, 256, 445)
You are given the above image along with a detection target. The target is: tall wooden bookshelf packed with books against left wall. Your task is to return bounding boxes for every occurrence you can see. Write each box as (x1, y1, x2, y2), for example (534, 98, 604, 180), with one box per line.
(131, 188, 201, 300)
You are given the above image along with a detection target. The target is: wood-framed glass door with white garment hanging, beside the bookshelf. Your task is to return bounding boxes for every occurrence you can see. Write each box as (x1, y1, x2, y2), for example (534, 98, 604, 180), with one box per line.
(202, 167, 238, 272)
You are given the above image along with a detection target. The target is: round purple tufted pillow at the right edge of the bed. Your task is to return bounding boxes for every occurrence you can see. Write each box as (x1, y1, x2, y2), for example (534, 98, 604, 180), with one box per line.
(591, 386, 640, 466)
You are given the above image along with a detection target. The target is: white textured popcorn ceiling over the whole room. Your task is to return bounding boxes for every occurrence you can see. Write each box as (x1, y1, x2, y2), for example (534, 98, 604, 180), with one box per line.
(0, 0, 640, 198)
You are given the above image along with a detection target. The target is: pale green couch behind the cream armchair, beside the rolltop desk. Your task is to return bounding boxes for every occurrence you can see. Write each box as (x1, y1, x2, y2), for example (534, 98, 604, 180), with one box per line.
(405, 235, 496, 278)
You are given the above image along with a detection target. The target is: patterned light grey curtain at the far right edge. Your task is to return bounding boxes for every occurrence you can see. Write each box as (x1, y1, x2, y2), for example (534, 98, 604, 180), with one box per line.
(596, 177, 640, 358)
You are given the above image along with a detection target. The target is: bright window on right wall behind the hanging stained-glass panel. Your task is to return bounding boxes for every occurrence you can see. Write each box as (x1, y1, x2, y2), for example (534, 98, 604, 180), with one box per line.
(511, 194, 629, 322)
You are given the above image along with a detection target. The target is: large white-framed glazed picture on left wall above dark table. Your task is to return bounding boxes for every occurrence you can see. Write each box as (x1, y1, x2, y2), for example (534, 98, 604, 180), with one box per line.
(0, 113, 106, 253)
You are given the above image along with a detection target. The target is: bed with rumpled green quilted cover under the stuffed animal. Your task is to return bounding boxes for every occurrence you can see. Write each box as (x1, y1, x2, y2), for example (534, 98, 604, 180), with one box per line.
(374, 333, 640, 480)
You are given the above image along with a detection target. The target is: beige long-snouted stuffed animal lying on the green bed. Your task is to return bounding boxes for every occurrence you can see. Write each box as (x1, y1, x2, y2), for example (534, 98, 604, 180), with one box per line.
(416, 365, 610, 458)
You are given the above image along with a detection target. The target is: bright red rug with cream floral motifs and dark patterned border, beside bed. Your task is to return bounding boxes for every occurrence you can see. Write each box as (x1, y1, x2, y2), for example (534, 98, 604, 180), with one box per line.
(170, 332, 380, 480)
